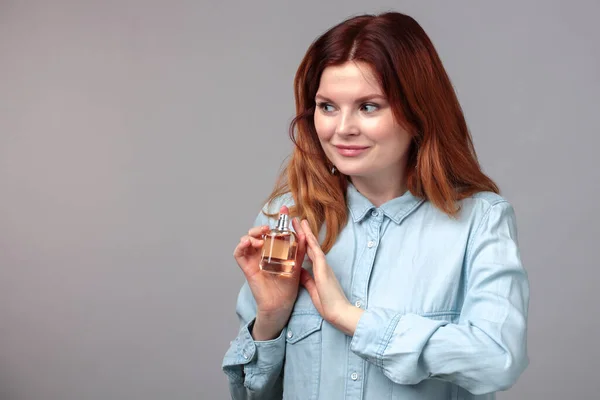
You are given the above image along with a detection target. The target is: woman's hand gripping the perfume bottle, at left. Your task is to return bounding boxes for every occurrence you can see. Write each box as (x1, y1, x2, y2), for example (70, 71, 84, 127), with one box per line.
(233, 206, 306, 340)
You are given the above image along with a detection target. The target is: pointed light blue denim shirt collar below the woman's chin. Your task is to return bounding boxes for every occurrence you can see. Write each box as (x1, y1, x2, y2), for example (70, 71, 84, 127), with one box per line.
(346, 182, 424, 224)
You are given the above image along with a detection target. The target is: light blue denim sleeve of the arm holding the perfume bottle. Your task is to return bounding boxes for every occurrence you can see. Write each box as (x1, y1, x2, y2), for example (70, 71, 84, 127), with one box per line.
(222, 206, 285, 400)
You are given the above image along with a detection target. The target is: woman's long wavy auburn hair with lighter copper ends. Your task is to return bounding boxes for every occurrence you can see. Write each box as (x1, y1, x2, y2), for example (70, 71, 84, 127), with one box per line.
(266, 12, 499, 253)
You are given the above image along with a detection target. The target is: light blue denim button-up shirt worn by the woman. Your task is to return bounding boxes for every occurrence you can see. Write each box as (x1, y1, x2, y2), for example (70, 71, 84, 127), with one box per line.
(223, 184, 529, 400)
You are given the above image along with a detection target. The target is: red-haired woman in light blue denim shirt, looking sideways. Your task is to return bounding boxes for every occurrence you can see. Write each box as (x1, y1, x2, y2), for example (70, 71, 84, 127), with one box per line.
(223, 13, 529, 400)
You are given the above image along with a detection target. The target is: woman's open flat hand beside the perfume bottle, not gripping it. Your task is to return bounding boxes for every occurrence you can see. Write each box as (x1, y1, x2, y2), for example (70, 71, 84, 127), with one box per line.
(296, 220, 363, 336)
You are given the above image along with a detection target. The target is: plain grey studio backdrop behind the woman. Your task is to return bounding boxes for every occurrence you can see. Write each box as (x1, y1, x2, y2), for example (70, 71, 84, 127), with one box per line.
(0, 0, 600, 400)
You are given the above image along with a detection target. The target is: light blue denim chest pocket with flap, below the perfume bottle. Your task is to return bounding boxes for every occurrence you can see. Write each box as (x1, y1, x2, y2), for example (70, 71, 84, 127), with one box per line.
(283, 311, 323, 400)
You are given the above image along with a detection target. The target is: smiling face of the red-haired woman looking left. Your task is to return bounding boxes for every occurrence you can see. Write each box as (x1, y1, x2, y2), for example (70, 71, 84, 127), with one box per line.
(314, 62, 411, 182)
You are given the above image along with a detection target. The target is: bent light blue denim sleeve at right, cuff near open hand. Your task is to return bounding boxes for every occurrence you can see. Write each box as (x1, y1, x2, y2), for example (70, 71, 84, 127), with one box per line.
(350, 201, 529, 394)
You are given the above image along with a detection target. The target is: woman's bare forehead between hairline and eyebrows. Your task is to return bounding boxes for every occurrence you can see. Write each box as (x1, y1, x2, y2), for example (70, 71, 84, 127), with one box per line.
(319, 61, 382, 94)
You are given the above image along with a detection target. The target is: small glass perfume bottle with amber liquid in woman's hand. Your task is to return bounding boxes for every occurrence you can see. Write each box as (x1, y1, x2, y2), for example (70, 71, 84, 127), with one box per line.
(259, 209, 298, 275)
